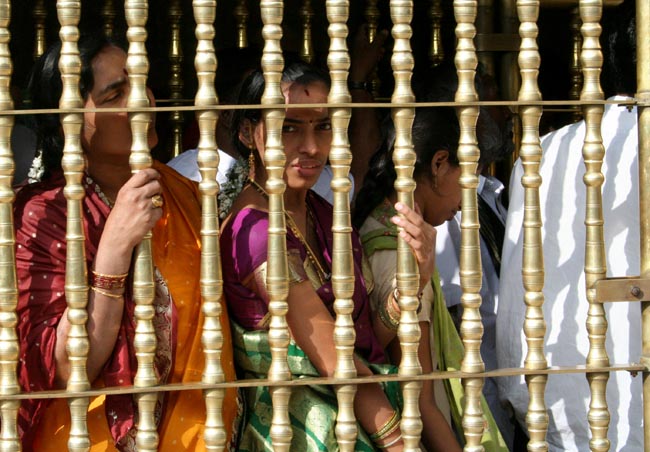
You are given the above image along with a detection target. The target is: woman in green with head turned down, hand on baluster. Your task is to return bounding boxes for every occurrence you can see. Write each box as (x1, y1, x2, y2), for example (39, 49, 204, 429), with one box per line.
(353, 107, 508, 452)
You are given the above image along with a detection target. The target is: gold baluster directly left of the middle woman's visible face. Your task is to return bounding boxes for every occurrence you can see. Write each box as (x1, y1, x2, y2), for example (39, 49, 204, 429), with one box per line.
(260, 0, 291, 452)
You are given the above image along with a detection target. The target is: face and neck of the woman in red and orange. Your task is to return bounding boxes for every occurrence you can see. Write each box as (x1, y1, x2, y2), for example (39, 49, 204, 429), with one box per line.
(81, 46, 158, 163)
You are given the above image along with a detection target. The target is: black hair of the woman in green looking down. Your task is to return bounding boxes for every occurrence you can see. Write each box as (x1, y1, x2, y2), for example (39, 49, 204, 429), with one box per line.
(352, 107, 460, 228)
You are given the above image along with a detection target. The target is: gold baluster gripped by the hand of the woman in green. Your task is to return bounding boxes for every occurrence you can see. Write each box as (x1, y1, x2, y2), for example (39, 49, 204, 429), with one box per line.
(390, 0, 422, 451)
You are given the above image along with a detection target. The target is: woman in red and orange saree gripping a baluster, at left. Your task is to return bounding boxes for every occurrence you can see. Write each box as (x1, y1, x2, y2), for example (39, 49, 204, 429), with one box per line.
(15, 33, 238, 451)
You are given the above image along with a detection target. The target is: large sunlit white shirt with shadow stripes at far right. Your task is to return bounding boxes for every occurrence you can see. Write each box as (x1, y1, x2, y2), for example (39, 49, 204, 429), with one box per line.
(497, 97, 643, 452)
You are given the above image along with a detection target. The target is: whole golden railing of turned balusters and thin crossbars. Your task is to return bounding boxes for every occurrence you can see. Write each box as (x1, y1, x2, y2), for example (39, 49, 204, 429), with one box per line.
(0, 0, 650, 451)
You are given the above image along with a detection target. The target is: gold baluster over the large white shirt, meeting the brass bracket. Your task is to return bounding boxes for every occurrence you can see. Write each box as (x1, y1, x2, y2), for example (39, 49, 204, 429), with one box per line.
(580, 0, 610, 452)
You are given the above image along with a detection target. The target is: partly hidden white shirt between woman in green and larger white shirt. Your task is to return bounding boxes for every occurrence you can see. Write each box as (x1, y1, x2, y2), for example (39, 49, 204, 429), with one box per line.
(436, 176, 514, 445)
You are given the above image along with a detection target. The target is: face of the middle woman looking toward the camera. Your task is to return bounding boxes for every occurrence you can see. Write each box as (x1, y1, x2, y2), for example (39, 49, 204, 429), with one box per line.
(248, 82, 332, 190)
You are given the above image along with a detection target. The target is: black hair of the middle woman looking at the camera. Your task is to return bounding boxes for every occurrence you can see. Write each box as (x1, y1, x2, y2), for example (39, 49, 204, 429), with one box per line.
(231, 61, 330, 158)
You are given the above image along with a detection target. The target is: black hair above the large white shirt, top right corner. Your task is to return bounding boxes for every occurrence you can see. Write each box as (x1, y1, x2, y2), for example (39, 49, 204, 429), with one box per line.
(601, 0, 636, 97)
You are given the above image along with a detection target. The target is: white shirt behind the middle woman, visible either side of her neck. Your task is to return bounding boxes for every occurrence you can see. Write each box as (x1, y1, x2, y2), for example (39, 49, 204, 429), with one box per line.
(167, 149, 354, 204)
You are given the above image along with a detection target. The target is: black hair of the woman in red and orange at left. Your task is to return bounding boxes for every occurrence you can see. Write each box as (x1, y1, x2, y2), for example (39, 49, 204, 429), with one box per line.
(27, 33, 124, 178)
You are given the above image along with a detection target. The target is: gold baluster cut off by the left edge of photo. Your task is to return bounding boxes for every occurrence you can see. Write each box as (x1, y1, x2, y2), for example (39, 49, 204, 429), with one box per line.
(0, 0, 20, 452)
